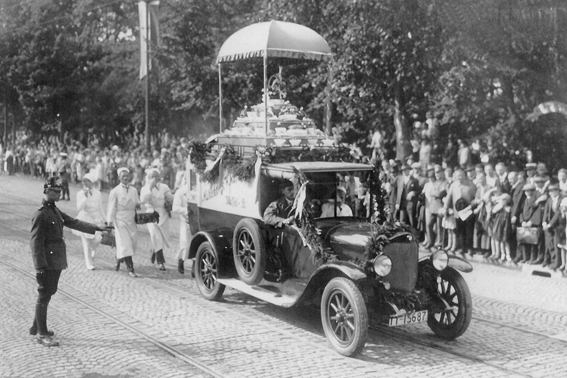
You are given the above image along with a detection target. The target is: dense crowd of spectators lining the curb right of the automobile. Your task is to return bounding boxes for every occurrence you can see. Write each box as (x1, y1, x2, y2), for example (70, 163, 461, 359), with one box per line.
(382, 157, 567, 270)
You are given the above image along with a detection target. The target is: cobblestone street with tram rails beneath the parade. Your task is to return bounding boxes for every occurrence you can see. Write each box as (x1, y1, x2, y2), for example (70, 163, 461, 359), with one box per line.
(0, 176, 567, 378)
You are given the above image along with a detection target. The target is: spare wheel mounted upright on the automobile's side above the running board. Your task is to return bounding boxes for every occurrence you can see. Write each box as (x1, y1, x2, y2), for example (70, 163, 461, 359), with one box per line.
(232, 218, 267, 285)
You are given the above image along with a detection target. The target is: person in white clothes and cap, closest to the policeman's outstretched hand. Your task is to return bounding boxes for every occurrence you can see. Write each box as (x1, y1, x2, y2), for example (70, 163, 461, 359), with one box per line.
(73, 172, 106, 270)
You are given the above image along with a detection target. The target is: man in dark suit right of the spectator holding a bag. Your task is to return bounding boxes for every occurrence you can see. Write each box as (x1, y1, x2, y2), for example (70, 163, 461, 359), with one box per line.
(541, 184, 563, 269)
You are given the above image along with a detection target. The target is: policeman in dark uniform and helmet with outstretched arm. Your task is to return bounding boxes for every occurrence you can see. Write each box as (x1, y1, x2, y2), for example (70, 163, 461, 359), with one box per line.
(30, 177, 111, 346)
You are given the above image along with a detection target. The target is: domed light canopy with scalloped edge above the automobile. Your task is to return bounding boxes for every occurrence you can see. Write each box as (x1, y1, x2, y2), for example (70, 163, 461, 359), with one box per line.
(217, 21, 333, 63)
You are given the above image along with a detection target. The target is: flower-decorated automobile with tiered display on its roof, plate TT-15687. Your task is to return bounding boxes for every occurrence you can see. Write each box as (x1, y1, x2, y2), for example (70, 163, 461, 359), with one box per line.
(187, 20, 472, 356)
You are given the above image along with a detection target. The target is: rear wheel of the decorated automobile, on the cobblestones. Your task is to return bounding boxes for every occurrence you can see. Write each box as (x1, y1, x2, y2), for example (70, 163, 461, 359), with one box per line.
(194, 242, 226, 301)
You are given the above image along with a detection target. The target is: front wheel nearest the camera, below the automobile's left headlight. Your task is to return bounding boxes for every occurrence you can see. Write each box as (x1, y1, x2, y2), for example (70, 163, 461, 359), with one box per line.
(321, 277, 368, 357)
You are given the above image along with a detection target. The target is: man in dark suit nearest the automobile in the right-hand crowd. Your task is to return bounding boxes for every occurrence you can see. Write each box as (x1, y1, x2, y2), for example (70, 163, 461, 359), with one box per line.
(392, 164, 420, 227)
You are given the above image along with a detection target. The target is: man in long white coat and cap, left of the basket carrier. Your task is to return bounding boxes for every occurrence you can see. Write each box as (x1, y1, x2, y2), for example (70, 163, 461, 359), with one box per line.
(106, 167, 140, 277)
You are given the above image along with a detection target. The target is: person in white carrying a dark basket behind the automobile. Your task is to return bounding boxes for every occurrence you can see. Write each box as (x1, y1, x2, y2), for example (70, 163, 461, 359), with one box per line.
(140, 168, 173, 270)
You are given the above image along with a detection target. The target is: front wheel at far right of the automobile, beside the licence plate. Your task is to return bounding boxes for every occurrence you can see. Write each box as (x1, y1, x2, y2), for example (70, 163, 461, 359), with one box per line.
(427, 267, 472, 340)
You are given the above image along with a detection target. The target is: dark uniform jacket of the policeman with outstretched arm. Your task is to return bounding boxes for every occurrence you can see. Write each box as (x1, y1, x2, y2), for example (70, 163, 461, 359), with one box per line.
(30, 200, 96, 270)
